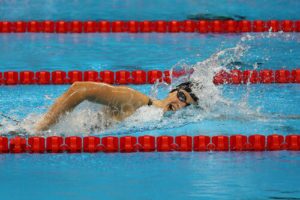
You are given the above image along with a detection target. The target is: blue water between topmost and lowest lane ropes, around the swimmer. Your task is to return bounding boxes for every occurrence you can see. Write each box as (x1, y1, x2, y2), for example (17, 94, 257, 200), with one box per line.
(0, 33, 300, 135)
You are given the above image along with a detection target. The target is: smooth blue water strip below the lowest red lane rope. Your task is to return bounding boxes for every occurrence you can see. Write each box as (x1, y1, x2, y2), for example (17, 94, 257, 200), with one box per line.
(0, 151, 300, 199)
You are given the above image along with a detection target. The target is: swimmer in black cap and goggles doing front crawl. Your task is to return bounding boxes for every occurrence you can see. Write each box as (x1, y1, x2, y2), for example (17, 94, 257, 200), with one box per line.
(35, 82, 198, 131)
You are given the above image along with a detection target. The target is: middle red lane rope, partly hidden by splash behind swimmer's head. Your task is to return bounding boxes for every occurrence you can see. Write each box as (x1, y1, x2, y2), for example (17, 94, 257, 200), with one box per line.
(0, 69, 300, 85)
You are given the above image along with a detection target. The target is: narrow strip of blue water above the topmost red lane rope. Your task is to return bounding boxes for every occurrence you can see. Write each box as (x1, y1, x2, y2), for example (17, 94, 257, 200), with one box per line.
(0, 0, 300, 20)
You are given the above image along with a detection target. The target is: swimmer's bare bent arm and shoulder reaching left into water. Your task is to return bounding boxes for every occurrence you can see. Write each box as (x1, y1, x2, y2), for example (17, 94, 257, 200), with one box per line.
(35, 82, 149, 131)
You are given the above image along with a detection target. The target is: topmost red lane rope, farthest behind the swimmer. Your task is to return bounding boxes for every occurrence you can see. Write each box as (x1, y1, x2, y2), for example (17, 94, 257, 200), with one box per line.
(0, 20, 300, 33)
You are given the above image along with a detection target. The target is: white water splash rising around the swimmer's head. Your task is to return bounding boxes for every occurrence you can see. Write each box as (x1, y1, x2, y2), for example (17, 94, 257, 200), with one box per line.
(102, 35, 258, 133)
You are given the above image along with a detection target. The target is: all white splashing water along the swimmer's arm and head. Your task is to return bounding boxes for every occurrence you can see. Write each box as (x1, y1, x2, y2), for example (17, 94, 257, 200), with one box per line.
(0, 32, 291, 135)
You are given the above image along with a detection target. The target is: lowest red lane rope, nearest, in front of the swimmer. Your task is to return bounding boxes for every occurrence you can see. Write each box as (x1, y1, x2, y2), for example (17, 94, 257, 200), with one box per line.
(0, 134, 300, 153)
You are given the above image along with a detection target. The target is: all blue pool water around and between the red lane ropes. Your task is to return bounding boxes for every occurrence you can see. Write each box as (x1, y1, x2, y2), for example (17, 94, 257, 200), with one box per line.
(0, 0, 300, 199)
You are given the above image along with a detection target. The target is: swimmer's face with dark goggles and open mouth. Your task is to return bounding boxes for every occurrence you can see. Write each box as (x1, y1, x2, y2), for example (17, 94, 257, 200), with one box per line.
(164, 90, 195, 112)
